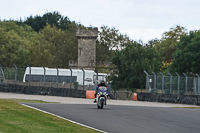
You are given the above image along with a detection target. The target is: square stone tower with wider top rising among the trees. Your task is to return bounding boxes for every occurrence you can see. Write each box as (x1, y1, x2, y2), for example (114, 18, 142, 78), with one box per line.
(76, 27, 98, 69)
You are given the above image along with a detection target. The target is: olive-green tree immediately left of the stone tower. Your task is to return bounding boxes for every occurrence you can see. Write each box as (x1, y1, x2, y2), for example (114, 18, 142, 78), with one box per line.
(30, 24, 78, 68)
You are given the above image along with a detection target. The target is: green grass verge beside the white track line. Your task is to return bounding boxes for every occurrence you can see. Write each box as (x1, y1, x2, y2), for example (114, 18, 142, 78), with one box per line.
(0, 99, 97, 133)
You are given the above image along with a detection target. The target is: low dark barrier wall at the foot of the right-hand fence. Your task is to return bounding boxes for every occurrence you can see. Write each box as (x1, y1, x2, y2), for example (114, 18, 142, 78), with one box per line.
(137, 92, 200, 105)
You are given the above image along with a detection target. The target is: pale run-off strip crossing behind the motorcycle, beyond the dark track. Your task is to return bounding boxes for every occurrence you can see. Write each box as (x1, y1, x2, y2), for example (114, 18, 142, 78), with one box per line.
(0, 92, 197, 107)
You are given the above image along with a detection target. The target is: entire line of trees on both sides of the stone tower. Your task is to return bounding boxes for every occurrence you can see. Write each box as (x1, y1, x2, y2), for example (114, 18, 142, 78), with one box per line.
(0, 12, 200, 90)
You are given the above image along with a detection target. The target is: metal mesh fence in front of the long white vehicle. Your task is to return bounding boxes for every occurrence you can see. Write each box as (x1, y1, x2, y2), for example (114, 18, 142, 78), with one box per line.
(0, 66, 100, 90)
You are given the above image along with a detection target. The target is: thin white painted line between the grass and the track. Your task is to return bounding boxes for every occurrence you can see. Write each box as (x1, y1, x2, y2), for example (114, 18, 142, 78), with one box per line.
(21, 103, 107, 133)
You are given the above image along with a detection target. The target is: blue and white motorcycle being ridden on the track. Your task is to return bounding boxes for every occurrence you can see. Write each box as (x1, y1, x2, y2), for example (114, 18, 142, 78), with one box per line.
(96, 86, 108, 109)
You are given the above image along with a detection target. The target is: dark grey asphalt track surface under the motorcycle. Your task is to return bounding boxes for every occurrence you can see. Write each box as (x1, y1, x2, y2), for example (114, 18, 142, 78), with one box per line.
(25, 103, 200, 133)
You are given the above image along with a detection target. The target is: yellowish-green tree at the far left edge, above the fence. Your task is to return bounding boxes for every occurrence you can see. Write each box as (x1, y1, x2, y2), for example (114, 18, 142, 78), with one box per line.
(0, 21, 35, 66)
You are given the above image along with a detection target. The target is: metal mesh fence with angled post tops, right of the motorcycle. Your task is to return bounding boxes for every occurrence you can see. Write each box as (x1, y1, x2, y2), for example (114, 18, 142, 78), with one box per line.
(144, 71, 200, 95)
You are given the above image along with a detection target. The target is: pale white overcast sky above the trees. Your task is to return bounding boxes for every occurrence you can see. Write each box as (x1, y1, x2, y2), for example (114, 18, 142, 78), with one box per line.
(0, 0, 200, 43)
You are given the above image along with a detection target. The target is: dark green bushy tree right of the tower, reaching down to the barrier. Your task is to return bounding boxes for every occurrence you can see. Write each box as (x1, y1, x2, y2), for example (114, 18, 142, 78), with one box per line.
(109, 42, 161, 89)
